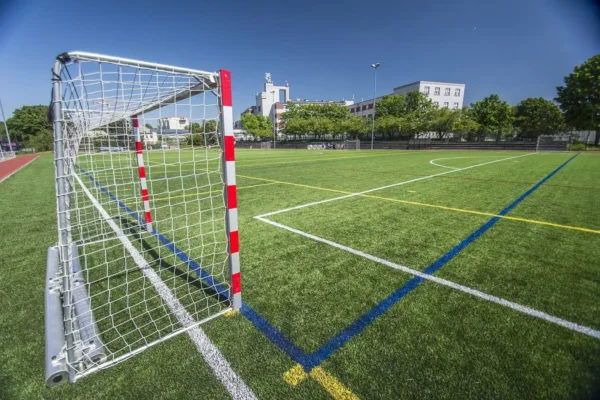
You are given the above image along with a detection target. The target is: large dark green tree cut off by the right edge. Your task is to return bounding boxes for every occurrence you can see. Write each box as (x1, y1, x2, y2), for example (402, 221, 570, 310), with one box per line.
(555, 54, 600, 145)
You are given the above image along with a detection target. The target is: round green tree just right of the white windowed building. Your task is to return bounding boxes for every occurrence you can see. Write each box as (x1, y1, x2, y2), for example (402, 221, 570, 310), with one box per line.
(471, 94, 514, 141)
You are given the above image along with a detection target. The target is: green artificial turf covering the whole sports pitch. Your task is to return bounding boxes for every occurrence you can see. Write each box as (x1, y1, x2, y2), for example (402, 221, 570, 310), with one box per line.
(0, 150, 600, 399)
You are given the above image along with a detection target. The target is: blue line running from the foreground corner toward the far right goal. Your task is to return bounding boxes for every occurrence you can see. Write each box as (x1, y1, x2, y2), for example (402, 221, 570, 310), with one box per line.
(302, 153, 579, 372)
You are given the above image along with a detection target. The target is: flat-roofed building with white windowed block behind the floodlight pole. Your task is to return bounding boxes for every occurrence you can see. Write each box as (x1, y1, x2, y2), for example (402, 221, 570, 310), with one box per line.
(348, 81, 465, 118)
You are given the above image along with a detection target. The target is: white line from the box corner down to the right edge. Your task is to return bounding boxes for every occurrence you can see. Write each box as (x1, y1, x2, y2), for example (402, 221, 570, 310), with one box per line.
(254, 216, 600, 339)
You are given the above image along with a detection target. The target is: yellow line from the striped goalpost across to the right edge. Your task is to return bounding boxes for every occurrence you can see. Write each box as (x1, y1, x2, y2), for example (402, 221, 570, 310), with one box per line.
(238, 174, 600, 234)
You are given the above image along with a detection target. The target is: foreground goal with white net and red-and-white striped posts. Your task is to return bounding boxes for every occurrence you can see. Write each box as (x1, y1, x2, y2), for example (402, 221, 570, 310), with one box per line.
(45, 52, 241, 386)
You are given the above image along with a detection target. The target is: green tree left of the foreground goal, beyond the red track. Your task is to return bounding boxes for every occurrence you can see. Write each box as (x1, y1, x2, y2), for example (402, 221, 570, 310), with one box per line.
(6, 105, 52, 142)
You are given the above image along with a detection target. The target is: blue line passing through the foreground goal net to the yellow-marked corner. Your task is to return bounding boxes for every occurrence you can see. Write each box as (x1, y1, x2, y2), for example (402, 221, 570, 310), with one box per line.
(75, 165, 308, 365)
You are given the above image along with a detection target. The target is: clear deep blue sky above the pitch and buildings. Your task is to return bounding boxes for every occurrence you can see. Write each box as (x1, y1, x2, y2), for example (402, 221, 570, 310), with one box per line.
(0, 0, 600, 117)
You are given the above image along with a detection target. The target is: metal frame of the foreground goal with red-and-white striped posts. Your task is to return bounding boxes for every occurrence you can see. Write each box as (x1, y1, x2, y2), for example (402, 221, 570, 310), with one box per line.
(45, 52, 242, 387)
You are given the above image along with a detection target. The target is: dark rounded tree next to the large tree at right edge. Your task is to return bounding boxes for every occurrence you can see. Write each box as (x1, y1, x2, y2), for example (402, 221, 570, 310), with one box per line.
(514, 97, 565, 139)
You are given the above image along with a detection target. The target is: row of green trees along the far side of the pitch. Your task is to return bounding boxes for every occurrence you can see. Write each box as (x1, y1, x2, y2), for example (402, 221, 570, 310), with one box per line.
(0, 54, 600, 151)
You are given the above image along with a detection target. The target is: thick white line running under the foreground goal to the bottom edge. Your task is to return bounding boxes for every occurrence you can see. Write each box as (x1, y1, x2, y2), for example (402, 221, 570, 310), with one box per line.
(73, 173, 256, 400)
